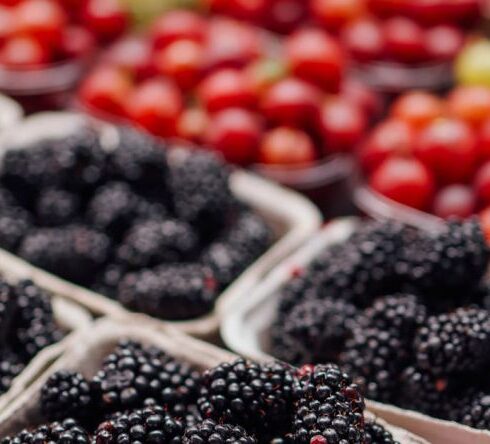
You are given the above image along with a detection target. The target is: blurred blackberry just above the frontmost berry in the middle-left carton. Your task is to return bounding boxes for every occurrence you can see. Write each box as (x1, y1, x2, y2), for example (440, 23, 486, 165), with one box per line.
(117, 219, 199, 268)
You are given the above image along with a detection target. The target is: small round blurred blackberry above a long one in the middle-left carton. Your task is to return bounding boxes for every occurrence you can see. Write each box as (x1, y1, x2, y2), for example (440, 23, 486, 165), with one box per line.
(36, 188, 80, 226)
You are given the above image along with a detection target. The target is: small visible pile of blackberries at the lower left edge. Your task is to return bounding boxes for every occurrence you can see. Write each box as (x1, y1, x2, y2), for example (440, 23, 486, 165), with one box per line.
(0, 277, 64, 394)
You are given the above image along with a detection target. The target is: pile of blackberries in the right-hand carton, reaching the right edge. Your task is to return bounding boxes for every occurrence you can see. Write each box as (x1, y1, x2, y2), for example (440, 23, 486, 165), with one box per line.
(270, 220, 490, 430)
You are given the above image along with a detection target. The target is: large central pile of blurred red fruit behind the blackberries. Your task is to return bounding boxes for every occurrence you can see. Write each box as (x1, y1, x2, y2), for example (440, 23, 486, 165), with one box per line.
(79, 10, 379, 165)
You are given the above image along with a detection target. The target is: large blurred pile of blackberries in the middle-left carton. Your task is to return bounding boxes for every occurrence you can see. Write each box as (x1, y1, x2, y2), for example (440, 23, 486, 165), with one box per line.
(0, 127, 271, 320)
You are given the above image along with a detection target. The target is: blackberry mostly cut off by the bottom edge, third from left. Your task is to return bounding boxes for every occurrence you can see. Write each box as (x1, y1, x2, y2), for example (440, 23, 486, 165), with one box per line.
(182, 419, 257, 444)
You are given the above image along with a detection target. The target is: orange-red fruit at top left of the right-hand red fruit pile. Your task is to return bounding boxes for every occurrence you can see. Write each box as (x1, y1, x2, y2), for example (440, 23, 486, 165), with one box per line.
(391, 91, 444, 128)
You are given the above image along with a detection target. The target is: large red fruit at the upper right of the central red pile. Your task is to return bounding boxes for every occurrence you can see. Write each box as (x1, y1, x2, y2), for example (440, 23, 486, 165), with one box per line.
(286, 29, 345, 92)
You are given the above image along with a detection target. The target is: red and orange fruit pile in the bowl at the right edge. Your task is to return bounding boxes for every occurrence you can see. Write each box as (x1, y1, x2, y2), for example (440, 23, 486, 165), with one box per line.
(359, 87, 490, 218)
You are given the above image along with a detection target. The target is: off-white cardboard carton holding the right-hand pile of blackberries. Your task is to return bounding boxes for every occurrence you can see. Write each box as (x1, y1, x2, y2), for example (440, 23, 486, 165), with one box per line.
(220, 217, 490, 444)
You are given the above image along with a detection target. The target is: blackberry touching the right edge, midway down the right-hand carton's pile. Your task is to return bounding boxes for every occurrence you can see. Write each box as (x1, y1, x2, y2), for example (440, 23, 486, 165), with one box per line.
(414, 308, 490, 375)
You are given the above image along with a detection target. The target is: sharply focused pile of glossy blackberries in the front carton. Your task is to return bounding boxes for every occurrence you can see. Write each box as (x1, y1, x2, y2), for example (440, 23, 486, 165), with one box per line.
(1, 340, 395, 444)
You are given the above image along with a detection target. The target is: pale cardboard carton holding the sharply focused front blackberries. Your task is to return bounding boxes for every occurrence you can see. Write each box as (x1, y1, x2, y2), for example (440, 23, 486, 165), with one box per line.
(0, 315, 428, 444)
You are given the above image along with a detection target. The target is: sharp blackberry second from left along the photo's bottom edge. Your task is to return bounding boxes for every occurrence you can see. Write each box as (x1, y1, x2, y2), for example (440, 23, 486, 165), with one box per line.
(93, 405, 184, 444)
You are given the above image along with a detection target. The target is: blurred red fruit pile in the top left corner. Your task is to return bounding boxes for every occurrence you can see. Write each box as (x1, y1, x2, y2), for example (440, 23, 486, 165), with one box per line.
(0, 0, 129, 69)
